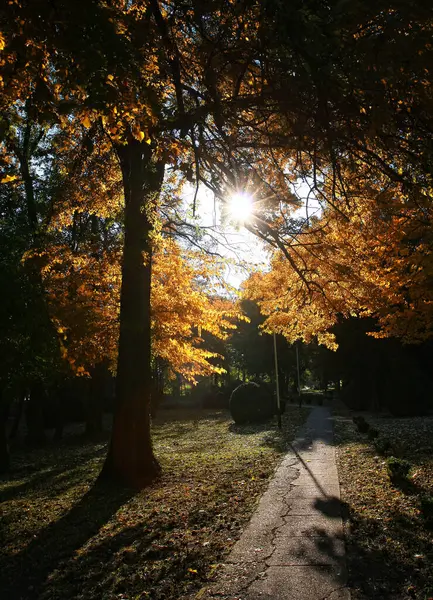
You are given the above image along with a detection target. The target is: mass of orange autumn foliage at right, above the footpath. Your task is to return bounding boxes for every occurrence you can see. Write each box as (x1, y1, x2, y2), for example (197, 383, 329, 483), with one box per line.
(246, 159, 433, 348)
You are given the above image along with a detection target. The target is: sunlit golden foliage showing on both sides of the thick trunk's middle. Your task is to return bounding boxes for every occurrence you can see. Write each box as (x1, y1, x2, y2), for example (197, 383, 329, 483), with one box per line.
(42, 237, 238, 382)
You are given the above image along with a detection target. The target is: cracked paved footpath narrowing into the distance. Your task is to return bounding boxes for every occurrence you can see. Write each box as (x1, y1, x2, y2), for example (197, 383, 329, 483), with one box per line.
(199, 407, 350, 600)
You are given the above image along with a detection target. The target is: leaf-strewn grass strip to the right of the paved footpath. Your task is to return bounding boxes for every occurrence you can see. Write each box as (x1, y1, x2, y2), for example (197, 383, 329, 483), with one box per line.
(336, 416, 433, 600)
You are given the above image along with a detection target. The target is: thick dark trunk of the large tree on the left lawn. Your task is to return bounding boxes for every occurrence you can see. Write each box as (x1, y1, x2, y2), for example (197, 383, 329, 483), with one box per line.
(101, 140, 164, 489)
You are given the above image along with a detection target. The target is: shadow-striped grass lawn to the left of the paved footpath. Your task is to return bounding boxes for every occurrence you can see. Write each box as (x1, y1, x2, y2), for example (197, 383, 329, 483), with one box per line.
(0, 407, 308, 600)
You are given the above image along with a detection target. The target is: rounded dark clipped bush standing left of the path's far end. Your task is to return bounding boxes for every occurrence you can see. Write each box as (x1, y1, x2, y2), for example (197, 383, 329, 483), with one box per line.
(230, 382, 275, 425)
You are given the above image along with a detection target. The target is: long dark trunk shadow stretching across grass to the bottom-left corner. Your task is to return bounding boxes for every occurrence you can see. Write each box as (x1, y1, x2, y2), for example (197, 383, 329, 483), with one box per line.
(0, 485, 132, 600)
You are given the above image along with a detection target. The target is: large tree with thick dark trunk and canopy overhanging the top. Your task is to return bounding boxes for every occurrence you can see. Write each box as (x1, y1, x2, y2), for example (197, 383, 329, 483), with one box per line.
(0, 0, 432, 487)
